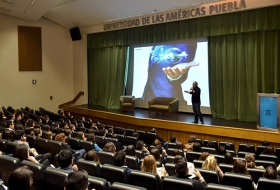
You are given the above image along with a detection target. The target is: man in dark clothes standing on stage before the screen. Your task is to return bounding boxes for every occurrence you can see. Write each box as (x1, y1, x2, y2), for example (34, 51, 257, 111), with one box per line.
(184, 81, 204, 124)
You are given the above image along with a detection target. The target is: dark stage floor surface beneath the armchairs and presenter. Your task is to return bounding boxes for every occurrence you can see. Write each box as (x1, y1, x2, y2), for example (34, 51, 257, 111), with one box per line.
(77, 105, 257, 129)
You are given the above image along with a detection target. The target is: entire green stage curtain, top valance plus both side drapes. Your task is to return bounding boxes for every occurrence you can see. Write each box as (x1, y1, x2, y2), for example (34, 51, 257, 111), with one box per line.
(88, 6, 280, 121)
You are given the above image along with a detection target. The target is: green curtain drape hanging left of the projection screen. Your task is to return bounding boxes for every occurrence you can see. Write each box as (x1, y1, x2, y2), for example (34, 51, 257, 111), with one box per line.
(87, 46, 128, 109)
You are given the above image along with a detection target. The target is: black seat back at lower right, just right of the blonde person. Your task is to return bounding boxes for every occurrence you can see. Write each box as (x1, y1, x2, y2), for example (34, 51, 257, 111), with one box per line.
(223, 172, 254, 190)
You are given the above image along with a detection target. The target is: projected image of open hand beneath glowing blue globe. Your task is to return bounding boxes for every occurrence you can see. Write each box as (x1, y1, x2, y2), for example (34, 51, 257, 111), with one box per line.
(132, 40, 209, 107)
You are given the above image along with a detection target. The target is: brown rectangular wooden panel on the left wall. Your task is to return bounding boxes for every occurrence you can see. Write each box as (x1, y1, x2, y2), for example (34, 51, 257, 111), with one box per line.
(18, 26, 42, 71)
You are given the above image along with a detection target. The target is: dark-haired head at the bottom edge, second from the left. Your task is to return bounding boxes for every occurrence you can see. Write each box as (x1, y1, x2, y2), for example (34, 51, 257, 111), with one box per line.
(64, 170, 88, 190)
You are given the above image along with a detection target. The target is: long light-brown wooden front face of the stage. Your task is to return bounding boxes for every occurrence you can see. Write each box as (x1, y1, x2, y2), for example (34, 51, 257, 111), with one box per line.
(63, 106, 280, 150)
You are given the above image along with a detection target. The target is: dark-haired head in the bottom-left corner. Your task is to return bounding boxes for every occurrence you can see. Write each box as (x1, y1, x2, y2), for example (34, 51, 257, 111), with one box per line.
(8, 166, 33, 190)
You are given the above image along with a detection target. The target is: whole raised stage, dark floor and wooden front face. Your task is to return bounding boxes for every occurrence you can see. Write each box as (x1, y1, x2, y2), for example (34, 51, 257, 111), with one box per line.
(63, 105, 280, 148)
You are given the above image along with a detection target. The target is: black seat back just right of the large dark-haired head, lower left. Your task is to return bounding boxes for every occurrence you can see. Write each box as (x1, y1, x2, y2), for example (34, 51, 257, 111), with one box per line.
(77, 158, 101, 177)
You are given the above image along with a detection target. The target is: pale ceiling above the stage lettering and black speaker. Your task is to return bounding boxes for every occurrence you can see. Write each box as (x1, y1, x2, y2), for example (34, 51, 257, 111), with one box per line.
(0, 0, 225, 28)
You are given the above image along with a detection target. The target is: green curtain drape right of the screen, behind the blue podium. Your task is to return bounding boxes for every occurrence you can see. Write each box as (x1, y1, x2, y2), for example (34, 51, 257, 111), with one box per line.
(209, 30, 280, 121)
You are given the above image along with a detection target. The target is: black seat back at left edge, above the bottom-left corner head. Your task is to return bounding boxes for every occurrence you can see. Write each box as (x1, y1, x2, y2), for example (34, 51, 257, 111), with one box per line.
(0, 156, 20, 185)
